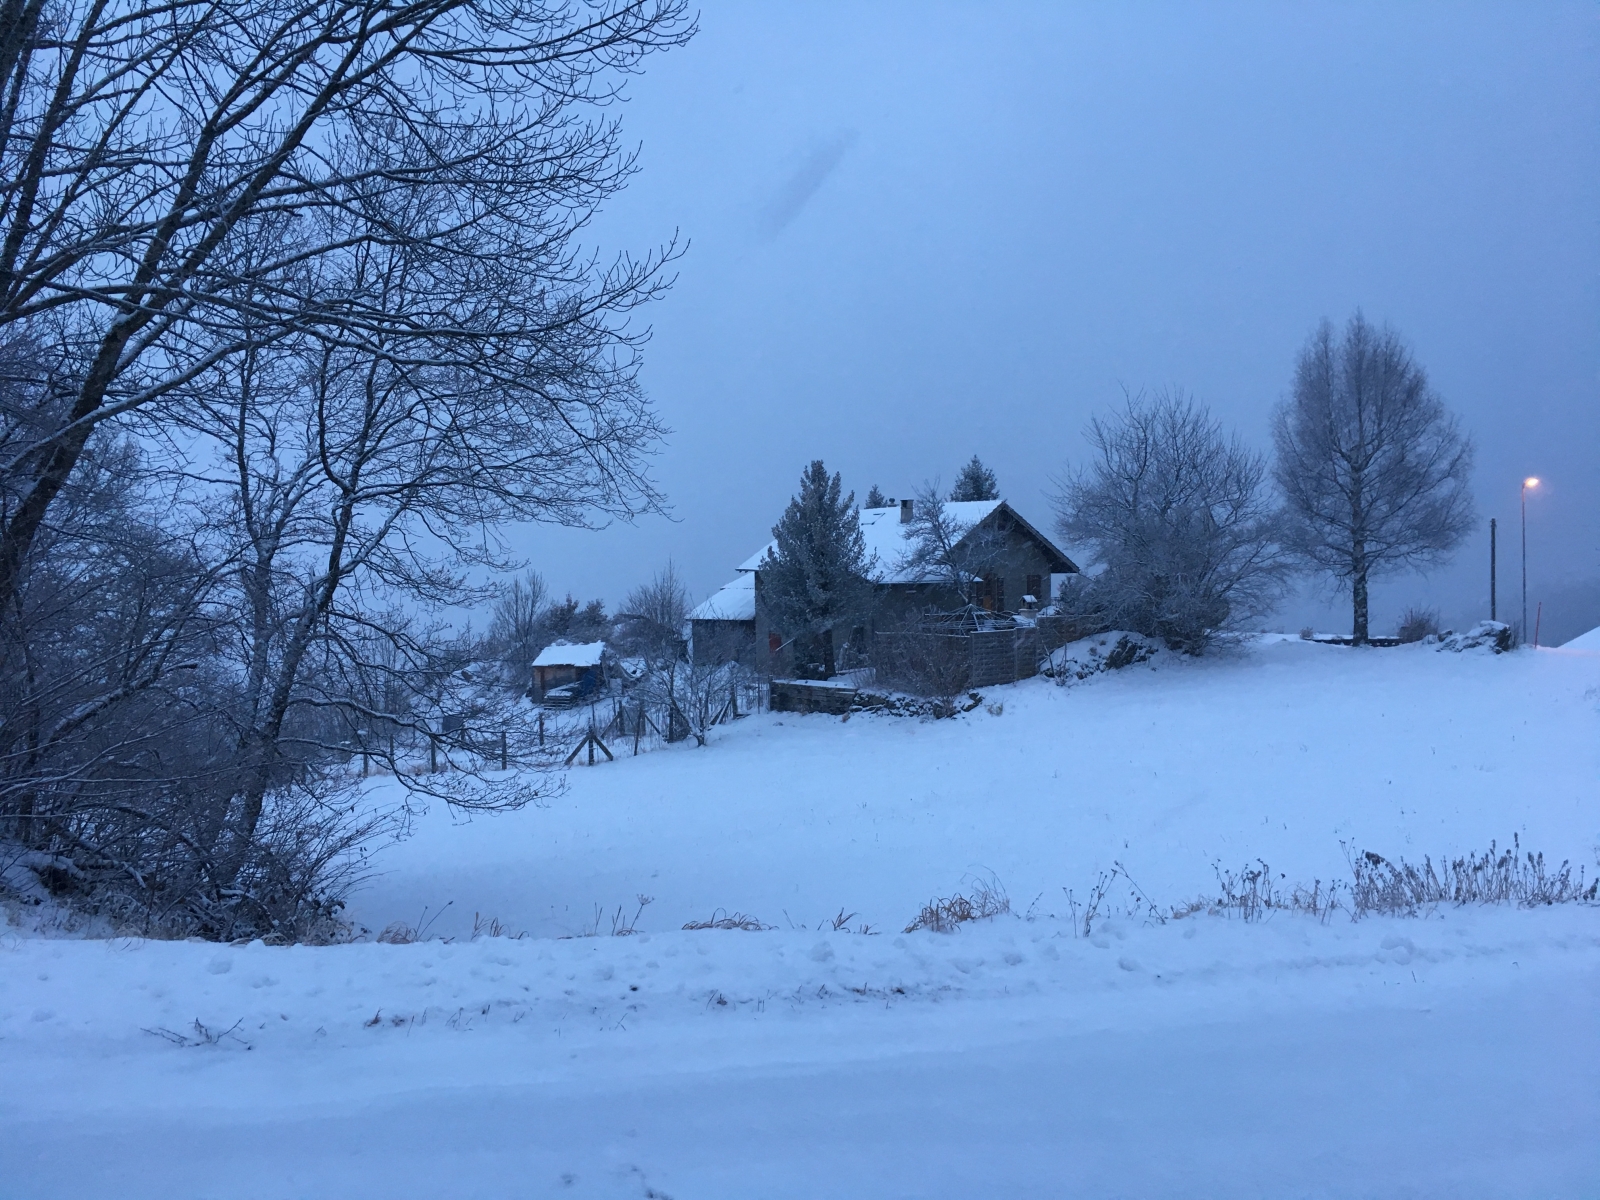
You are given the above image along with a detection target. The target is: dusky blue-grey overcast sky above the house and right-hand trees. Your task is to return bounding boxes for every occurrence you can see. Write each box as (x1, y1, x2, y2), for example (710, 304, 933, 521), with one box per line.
(510, 0, 1600, 634)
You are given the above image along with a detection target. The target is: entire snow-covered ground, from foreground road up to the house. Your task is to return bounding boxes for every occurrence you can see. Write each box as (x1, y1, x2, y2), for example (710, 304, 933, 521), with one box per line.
(0, 640, 1600, 1200)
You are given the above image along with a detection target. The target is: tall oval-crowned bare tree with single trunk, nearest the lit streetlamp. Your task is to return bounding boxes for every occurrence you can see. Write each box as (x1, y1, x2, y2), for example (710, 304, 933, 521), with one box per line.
(1272, 312, 1474, 643)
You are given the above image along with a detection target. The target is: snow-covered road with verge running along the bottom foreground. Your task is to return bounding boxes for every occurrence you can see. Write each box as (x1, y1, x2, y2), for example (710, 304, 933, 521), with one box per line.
(0, 906, 1600, 1200)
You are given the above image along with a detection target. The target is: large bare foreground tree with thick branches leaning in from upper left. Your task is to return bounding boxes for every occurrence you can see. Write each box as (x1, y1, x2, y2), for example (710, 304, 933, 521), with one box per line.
(0, 0, 693, 620)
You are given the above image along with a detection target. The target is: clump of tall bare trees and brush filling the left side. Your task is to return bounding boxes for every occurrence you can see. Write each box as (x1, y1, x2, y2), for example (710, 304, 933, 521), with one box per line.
(0, 0, 691, 938)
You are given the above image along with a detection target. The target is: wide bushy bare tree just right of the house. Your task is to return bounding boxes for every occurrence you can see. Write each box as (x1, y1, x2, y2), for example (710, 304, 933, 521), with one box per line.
(1056, 392, 1285, 653)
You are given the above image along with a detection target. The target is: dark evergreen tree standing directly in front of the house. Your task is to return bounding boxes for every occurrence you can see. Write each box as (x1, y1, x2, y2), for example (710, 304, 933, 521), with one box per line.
(760, 459, 874, 678)
